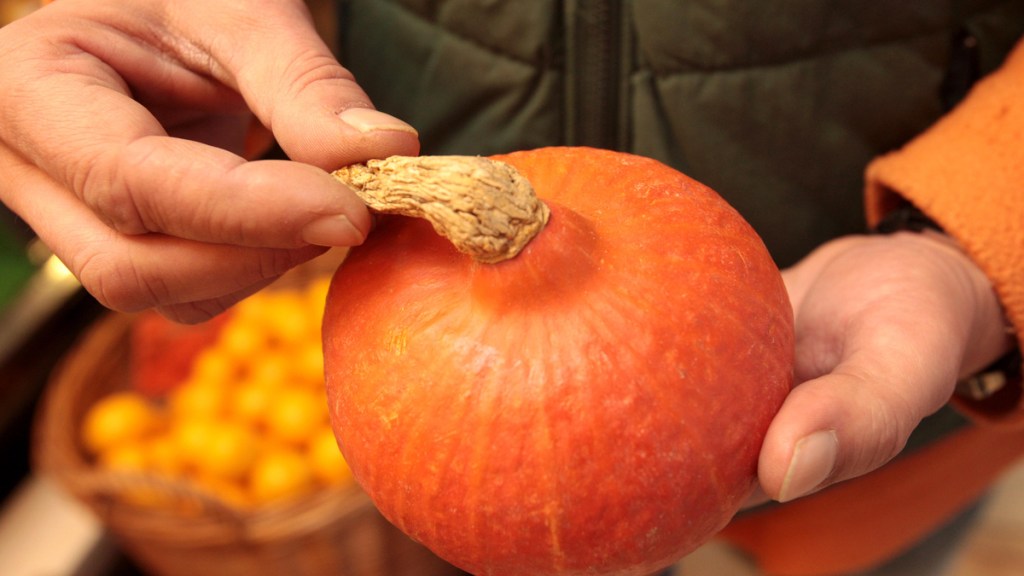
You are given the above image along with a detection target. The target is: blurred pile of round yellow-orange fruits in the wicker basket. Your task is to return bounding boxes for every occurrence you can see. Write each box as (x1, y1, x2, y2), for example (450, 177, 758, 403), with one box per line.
(81, 278, 353, 507)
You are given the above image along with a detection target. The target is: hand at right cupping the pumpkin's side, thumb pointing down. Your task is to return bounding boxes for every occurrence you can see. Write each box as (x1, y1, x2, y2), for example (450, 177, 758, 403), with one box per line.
(759, 232, 1012, 501)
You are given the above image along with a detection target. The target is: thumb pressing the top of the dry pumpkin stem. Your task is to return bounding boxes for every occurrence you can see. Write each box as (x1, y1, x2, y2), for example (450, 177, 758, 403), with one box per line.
(182, 0, 419, 170)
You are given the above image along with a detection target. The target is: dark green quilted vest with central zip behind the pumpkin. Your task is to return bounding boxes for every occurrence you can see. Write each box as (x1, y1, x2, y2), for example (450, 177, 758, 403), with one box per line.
(339, 0, 1024, 265)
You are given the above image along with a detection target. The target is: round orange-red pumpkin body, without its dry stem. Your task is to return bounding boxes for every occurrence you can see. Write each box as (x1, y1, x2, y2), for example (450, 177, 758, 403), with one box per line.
(324, 148, 794, 576)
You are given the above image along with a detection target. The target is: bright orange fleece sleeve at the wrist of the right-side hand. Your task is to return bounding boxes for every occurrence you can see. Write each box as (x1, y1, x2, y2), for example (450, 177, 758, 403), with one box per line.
(865, 36, 1024, 424)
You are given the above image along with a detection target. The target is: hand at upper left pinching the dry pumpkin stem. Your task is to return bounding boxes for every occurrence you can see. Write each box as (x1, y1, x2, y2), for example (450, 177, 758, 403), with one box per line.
(0, 0, 419, 322)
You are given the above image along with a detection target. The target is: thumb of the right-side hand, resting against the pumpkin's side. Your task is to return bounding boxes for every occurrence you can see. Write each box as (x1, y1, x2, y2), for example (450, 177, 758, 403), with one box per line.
(758, 338, 955, 501)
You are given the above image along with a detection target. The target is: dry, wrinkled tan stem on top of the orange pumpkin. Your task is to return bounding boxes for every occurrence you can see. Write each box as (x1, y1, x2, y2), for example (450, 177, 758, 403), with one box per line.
(331, 156, 551, 263)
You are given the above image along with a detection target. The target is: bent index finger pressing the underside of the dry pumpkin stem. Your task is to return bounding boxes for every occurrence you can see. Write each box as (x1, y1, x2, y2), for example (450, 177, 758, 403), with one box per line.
(95, 137, 371, 248)
